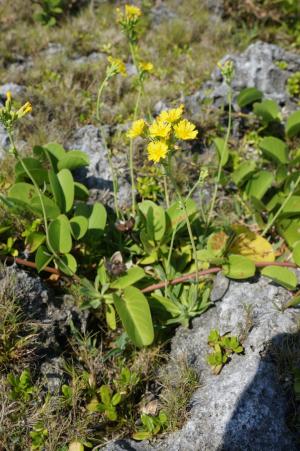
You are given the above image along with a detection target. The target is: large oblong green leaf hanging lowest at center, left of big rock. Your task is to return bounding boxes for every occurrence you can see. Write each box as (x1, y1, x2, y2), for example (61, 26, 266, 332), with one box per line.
(113, 287, 154, 347)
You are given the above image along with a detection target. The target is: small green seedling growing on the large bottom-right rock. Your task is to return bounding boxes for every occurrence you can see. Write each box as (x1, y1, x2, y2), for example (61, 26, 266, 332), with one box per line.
(207, 329, 244, 375)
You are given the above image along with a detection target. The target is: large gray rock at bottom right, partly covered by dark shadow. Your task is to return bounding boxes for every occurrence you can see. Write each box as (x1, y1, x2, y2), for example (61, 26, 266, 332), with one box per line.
(106, 278, 299, 451)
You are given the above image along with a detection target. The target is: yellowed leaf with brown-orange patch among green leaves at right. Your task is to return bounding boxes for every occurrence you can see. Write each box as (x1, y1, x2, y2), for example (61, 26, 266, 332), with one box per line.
(230, 225, 275, 262)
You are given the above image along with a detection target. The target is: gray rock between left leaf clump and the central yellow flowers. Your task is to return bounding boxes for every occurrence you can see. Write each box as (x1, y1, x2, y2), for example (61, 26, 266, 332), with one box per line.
(66, 125, 130, 207)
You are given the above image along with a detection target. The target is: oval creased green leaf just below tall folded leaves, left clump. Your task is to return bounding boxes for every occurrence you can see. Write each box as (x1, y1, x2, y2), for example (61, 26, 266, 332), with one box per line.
(49, 215, 72, 254)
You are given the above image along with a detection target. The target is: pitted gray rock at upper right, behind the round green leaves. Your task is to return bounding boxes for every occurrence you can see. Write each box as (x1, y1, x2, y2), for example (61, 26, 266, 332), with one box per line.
(186, 41, 300, 119)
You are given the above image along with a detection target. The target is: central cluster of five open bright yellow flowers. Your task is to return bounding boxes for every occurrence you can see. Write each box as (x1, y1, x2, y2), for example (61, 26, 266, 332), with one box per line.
(127, 105, 198, 163)
